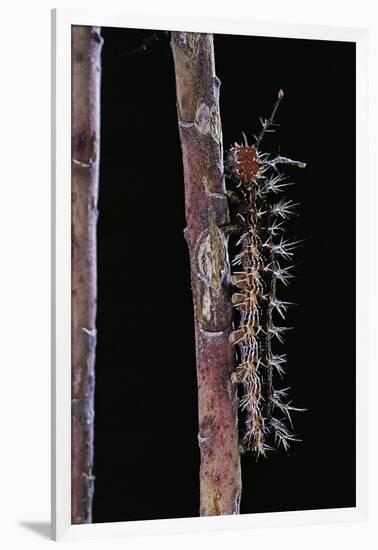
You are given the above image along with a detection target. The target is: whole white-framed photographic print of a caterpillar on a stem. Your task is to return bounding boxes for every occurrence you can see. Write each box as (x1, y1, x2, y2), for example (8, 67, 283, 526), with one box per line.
(52, 9, 368, 540)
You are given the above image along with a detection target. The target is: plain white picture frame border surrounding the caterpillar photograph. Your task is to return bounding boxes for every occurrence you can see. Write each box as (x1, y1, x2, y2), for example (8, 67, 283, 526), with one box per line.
(52, 7, 368, 540)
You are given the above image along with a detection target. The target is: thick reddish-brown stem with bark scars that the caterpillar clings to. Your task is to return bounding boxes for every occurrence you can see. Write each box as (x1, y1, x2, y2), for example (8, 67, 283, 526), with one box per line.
(171, 32, 241, 516)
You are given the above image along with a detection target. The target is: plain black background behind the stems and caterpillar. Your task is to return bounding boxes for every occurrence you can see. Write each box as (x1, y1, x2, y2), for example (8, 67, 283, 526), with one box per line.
(94, 28, 355, 522)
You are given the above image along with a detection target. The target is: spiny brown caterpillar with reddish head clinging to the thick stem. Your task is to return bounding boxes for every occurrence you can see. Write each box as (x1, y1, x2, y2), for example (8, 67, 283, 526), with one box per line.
(226, 90, 305, 456)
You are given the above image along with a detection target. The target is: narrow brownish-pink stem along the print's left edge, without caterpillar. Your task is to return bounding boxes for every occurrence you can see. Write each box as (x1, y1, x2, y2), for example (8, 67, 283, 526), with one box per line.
(71, 26, 102, 523)
